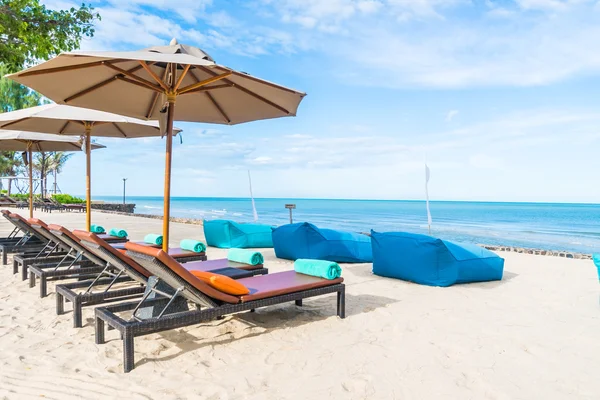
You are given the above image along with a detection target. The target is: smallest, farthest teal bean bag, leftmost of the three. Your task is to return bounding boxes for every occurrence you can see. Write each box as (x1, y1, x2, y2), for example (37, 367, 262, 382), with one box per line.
(204, 219, 273, 249)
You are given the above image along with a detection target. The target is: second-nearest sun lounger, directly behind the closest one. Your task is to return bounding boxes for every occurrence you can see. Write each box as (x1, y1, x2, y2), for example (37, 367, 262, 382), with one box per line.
(56, 230, 268, 328)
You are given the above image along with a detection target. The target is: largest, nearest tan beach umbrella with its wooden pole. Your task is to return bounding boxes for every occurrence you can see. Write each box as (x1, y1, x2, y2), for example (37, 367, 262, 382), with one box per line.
(8, 40, 305, 250)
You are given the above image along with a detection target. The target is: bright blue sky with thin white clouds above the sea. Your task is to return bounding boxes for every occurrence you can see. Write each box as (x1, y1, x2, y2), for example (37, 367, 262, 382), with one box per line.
(44, 0, 600, 202)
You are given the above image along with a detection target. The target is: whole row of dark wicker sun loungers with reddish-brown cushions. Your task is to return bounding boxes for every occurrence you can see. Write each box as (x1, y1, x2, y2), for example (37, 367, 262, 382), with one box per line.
(0, 211, 345, 372)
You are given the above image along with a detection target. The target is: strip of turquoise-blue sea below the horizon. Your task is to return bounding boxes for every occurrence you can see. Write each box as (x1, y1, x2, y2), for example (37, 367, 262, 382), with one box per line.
(94, 196, 600, 253)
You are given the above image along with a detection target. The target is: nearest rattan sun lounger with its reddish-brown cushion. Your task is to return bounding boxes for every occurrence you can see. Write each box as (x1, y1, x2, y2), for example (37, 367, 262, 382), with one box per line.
(95, 244, 345, 372)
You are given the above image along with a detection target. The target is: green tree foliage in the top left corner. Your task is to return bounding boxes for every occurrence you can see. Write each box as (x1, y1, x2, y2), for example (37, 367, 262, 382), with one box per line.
(0, 0, 100, 72)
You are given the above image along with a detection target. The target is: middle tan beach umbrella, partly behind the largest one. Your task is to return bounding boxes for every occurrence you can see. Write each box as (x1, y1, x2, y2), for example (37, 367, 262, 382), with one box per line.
(0, 104, 180, 230)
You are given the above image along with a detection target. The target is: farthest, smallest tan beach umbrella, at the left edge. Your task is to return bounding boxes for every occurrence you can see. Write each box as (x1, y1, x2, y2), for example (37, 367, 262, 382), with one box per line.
(0, 130, 106, 218)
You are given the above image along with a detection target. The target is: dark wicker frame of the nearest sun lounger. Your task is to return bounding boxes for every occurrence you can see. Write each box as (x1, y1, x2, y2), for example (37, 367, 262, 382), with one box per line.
(95, 252, 346, 372)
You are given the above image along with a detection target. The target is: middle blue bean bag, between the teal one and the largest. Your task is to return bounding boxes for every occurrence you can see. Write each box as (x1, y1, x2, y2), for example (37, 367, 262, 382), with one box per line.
(273, 222, 373, 263)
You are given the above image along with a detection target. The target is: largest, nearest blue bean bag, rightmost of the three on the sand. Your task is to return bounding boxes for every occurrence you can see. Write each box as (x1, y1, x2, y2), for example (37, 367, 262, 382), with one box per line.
(371, 231, 504, 286)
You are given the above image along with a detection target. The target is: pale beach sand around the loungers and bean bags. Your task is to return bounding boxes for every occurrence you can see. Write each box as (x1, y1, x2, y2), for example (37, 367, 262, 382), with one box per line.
(0, 212, 600, 400)
